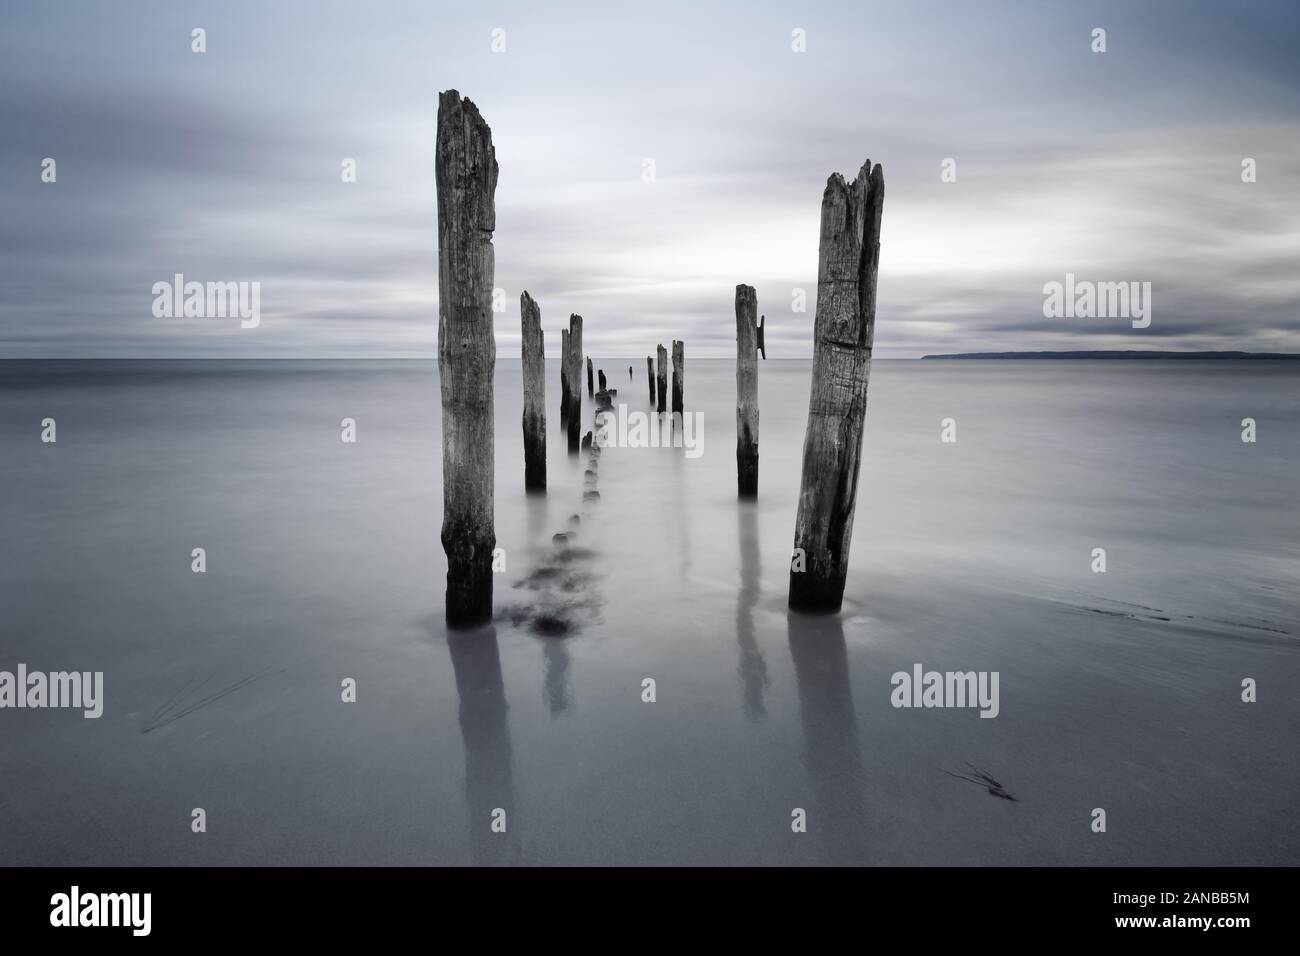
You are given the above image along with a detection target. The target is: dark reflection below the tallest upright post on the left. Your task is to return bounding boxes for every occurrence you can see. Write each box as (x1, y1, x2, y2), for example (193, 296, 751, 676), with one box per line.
(447, 626, 520, 866)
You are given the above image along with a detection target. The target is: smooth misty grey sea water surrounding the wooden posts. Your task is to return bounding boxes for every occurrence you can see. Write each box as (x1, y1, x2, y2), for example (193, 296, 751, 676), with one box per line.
(0, 355, 1300, 865)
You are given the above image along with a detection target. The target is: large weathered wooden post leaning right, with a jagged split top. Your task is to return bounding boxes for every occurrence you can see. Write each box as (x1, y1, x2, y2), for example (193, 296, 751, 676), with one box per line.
(789, 160, 885, 611)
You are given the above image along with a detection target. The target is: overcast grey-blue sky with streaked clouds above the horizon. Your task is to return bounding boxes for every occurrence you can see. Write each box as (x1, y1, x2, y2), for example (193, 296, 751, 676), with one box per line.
(0, 0, 1300, 358)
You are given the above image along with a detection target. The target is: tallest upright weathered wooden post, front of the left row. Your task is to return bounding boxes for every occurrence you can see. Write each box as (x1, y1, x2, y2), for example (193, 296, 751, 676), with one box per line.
(434, 90, 497, 627)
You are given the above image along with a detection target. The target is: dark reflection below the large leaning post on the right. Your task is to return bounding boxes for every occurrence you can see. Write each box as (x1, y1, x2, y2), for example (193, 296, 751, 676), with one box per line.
(787, 611, 870, 864)
